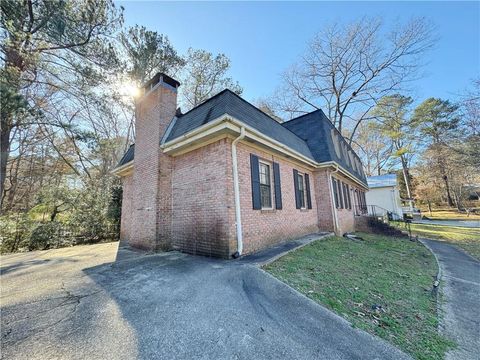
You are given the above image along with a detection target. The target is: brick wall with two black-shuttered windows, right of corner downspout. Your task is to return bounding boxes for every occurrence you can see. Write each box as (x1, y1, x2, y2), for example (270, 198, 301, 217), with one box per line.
(235, 143, 318, 254)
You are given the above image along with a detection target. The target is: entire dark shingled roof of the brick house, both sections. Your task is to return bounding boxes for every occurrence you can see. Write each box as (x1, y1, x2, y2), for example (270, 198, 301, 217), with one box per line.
(118, 89, 367, 184)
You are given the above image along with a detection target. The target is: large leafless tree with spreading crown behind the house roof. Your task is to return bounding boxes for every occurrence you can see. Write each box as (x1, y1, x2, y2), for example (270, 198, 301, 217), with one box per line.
(274, 18, 436, 140)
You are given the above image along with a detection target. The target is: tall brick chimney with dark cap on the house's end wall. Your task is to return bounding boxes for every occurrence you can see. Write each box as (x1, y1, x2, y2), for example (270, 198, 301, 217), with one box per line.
(130, 73, 180, 250)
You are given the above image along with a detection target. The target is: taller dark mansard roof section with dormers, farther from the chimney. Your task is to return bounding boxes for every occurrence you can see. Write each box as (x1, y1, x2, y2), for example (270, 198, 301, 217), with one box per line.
(282, 110, 367, 184)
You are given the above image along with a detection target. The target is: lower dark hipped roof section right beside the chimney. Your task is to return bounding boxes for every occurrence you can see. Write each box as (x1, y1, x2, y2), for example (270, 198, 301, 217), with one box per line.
(165, 89, 314, 160)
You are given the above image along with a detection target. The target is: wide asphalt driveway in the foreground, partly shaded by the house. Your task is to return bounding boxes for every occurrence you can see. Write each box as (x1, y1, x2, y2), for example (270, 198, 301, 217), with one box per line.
(1, 243, 407, 359)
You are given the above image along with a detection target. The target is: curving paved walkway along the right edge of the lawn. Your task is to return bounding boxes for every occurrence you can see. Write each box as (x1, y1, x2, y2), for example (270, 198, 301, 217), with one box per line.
(423, 240, 480, 360)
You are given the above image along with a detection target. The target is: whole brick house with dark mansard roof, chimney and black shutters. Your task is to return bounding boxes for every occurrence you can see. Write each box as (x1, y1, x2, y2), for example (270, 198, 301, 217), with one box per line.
(114, 73, 368, 258)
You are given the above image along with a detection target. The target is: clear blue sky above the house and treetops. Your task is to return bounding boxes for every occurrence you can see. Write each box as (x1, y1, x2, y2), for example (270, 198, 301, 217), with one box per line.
(118, 1, 480, 102)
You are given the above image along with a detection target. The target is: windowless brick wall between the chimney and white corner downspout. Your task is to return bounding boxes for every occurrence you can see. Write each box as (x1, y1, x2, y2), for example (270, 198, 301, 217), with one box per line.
(172, 139, 236, 258)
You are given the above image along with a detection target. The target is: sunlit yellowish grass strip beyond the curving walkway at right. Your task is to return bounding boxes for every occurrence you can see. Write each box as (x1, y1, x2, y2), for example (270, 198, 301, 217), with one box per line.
(399, 224, 480, 259)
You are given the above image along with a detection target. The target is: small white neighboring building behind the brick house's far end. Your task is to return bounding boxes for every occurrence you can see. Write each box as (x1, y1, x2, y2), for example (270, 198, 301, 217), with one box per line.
(365, 174, 403, 217)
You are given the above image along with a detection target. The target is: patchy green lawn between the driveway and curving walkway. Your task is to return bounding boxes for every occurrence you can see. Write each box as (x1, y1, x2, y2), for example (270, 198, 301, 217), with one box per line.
(265, 234, 453, 359)
